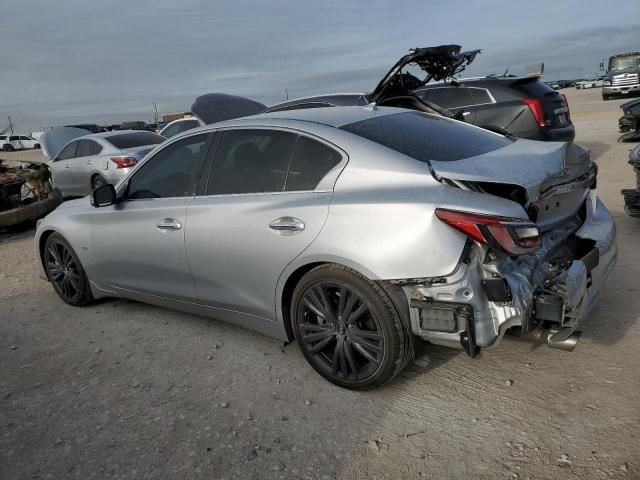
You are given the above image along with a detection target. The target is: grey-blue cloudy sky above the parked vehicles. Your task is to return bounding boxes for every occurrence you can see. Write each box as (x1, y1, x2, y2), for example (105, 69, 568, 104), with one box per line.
(0, 0, 640, 133)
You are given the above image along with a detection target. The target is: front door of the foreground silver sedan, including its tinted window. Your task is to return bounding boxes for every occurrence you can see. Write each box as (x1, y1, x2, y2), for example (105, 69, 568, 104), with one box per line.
(91, 134, 212, 300)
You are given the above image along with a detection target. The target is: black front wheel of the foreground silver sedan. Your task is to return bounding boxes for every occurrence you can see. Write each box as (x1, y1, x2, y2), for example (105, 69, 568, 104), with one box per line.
(43, 233, 93, 306)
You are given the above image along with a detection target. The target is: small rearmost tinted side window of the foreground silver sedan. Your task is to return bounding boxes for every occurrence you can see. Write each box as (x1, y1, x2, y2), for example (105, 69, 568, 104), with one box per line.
(285, 137, 342, 192)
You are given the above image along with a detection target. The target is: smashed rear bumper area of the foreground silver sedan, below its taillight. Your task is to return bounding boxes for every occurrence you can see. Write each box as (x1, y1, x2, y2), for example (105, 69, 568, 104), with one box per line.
(402, 191, 617, 356)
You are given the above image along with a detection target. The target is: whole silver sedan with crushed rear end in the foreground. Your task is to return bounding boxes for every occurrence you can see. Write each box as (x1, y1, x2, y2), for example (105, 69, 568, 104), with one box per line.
(35, 105, 617, 388)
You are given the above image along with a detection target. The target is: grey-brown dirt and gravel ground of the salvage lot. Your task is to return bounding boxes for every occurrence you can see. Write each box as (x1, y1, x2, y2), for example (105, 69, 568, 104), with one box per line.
(0, 90, 640, 479)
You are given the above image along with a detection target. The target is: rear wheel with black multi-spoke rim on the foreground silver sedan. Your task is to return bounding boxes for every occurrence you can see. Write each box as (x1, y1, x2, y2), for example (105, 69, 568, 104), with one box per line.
(291, 264, 408, 389)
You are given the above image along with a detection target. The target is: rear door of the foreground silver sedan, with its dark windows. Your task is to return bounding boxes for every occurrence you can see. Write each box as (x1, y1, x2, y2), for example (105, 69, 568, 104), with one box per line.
(186, 129, 347, 321)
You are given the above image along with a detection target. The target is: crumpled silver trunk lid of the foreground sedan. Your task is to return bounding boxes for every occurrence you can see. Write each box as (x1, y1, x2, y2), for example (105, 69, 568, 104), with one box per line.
(430, 140, 596, 231)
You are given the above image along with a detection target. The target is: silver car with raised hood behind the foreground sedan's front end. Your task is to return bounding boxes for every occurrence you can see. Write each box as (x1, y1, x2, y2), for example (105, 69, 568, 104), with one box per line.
(41, 127, 165, 197)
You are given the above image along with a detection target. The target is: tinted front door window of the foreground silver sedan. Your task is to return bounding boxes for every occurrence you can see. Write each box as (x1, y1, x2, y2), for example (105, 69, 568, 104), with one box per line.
(127, 133, 212, 199)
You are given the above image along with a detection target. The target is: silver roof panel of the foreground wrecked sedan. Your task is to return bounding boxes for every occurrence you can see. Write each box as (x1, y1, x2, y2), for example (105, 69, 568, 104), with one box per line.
(211, 105, 412, 128)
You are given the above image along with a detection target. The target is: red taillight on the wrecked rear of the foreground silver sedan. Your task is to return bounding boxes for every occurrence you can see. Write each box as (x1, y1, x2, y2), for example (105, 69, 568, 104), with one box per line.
(436, 208, 540, 255)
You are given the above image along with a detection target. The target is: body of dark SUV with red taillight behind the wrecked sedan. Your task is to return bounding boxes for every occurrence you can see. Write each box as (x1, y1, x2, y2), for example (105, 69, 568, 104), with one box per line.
(415, 77, 575, 142)
